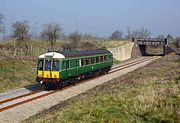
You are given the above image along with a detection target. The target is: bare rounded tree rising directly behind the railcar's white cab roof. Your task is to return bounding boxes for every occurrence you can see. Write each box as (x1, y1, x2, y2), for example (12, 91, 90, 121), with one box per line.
(41, 23, 63, 49)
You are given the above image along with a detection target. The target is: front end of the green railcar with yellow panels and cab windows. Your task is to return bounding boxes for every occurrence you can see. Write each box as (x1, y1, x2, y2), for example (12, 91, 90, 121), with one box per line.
(36, 52, 64, 87)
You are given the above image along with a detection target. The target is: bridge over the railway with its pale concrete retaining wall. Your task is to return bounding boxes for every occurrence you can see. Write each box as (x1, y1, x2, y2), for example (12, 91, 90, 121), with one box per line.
(109, 38, 174, 61)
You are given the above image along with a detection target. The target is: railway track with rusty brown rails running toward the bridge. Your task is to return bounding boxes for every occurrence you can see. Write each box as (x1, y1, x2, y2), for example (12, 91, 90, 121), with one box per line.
(0, 57, 157, 112)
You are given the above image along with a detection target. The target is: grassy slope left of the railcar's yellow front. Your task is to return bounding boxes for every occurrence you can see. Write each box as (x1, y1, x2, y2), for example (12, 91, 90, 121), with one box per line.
(0, 59, 36, 92)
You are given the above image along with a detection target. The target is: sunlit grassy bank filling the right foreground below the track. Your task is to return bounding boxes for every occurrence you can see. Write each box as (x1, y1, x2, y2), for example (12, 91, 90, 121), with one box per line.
(24, 54, 180, 123)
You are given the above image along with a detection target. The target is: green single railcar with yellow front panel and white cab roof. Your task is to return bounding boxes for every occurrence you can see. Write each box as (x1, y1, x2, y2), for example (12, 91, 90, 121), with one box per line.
(36, 49, 113, 87)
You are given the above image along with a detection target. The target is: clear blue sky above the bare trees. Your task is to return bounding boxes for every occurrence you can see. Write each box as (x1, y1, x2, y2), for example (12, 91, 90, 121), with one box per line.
(0, 0, 180, 37)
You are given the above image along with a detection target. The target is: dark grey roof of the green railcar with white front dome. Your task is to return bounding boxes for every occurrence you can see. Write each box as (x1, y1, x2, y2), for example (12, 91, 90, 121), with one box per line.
(39, 49, 111, 58)
